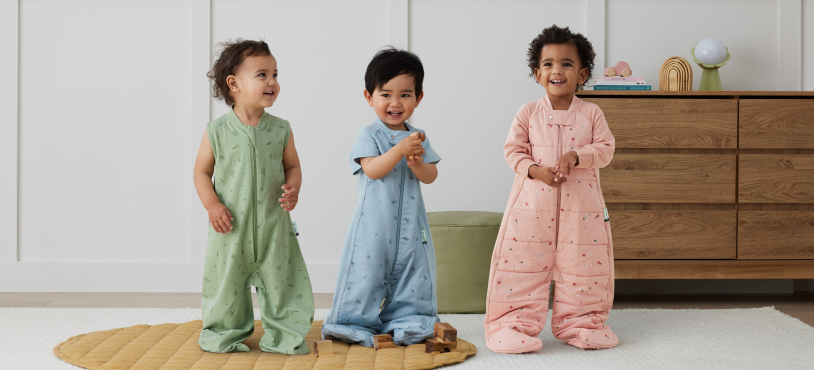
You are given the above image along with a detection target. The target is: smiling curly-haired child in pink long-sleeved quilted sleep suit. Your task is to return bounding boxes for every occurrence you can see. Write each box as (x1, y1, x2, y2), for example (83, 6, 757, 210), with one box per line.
(484, 25, 619, 353)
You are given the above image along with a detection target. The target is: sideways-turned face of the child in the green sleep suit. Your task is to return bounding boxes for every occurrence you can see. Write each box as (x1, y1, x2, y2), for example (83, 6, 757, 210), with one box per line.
(226, 55, 280, 109)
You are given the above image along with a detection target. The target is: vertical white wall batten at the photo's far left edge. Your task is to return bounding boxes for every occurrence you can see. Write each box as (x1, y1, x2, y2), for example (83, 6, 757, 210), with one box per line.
(0, 0, 20, 262)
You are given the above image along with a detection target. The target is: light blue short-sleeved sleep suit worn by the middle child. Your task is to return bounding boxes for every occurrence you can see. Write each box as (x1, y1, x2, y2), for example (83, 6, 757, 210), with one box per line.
(322, 120, 441, 347)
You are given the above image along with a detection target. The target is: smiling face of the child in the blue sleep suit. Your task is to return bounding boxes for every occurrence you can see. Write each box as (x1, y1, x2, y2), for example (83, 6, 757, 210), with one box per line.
(365, 74, 424, 130)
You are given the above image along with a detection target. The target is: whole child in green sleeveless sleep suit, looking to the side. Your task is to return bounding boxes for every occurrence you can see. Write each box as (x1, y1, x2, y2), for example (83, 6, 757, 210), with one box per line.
(195, 39, 314, 354)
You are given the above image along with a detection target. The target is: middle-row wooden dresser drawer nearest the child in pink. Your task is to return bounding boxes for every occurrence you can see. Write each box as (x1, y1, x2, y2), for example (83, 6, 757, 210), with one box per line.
(600, 153, 736, 203)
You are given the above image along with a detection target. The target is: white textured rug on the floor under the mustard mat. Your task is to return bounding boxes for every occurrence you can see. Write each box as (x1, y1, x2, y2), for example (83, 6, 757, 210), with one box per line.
(0, 307, 814, 370)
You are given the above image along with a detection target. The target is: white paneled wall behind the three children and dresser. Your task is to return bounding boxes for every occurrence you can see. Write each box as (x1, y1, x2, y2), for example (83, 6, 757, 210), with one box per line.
(0, 0, 814, 292)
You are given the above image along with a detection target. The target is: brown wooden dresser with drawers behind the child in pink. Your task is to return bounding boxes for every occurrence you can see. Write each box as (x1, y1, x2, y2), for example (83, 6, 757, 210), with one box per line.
(578, 91, 814, 279)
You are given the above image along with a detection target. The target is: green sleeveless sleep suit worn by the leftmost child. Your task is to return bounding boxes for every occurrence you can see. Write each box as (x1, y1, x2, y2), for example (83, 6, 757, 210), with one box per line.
(198, 109, 314, 354)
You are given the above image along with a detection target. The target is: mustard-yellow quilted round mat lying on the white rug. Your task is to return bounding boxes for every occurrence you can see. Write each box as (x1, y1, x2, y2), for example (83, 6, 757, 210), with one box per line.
(54, 320, 476, 370)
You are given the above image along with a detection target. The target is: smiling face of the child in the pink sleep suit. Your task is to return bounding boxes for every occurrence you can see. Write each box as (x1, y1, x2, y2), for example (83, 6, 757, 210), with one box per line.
(534, 43, 588, 98)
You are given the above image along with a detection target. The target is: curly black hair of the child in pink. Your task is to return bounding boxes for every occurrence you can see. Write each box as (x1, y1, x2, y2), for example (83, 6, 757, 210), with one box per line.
(526, 24, 596, 91)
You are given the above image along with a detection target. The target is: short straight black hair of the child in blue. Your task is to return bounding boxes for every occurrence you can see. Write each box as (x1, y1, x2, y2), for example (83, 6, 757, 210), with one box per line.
(365, 46, 424, 99)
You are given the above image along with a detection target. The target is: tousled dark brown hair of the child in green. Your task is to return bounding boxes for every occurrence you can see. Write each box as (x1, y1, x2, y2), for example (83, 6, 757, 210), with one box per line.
(206, 38, 271, 107)
